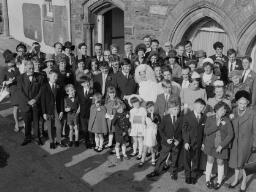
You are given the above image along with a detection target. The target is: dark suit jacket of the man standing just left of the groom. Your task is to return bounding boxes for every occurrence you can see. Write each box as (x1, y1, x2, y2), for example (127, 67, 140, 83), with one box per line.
(93, 73, 113, 95)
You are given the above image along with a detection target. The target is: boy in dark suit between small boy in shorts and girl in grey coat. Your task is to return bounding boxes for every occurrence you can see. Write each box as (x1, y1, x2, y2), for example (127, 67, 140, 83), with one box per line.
(76, 75, 94, 148)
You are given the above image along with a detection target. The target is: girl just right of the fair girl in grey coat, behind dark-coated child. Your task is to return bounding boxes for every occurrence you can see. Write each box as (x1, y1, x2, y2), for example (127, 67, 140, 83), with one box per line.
(105, 87, 120, 148)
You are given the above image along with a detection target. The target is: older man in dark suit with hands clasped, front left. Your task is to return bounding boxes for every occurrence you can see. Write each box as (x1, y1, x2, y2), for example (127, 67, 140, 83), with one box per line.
(18, 61, 44, 145)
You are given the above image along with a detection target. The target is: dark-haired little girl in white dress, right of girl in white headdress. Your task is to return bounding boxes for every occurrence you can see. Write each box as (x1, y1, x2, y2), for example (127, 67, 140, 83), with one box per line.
(139, 101, 160, 167)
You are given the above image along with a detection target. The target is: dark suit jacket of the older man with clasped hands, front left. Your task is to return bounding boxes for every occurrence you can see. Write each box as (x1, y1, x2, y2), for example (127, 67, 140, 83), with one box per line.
(18, 73, 44, 112)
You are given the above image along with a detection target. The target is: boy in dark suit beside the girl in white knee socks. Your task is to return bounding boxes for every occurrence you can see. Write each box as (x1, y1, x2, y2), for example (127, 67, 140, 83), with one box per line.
(182, 99, 206, 184)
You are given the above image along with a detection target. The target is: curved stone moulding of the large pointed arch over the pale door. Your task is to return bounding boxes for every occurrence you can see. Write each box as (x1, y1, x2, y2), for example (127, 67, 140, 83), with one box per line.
(160, 1, 237, 49)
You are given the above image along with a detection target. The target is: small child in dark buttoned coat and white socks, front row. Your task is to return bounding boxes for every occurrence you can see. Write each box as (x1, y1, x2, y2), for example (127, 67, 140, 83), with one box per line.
(112, 100, 130, 159)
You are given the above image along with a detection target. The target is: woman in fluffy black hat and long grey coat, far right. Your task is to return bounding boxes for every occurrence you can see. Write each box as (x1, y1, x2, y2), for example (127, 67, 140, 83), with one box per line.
(229, 90, 256, 192)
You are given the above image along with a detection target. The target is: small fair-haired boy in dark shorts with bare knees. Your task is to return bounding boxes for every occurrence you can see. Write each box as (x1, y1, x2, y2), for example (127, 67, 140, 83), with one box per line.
(64, 84, 80, 147)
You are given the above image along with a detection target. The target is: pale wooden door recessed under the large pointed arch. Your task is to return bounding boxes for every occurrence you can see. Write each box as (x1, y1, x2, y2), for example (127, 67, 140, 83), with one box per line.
(182, 17, 232, 56)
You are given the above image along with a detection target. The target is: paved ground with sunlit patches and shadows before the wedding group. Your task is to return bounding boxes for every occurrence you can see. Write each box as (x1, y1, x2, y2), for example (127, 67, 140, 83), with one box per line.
(0, 38, 256, 192)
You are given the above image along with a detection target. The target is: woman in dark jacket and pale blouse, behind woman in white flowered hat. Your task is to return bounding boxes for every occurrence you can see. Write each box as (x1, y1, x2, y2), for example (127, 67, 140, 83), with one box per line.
(202, 62, 219, 98)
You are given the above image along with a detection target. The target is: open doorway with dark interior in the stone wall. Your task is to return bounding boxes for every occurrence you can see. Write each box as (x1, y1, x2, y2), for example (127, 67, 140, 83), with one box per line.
(83, 0, 124, 54)
